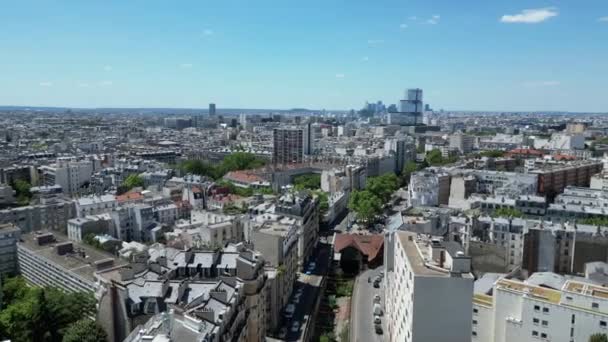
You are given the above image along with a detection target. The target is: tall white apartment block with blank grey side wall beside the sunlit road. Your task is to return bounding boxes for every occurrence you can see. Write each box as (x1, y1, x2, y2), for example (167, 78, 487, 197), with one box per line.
(384, 231, 473, 342)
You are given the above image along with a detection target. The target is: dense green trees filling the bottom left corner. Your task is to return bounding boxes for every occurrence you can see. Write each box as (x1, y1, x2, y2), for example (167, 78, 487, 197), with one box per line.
(0, 277, 107, 342)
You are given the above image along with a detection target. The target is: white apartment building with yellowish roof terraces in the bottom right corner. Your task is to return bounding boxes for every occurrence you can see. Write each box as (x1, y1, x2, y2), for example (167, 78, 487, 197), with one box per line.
(472, 279, 608, 342)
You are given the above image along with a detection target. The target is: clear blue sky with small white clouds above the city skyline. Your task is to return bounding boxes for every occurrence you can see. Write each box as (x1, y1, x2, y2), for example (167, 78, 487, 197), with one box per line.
(0, 0, 608, 112)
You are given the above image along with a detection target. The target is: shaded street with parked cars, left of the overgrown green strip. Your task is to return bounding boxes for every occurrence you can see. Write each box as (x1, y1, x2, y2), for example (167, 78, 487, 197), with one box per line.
(283, 242, 331, 341)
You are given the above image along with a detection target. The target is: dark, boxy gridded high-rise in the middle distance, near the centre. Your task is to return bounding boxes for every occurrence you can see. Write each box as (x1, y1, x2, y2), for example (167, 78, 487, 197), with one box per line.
(272, 128, 304, 165)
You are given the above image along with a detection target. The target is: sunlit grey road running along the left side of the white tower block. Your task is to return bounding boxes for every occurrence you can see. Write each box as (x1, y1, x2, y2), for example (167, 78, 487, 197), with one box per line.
(350, 266, 387, 342)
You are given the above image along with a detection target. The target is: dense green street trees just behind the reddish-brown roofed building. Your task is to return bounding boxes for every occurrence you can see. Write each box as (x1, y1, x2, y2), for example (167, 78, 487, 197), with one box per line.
(348, 173, 400, 224)
